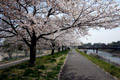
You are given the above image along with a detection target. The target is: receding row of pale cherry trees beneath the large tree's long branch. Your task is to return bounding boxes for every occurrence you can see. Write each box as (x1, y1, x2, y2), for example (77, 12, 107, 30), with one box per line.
(43, 28, 85, 55)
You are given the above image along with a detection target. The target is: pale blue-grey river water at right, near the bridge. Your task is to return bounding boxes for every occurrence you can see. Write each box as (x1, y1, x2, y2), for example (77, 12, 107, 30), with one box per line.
(87, 50, 120, 65)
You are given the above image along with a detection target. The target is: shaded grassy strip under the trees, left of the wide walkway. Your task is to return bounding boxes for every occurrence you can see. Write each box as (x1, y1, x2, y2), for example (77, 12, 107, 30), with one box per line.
(0, 50, 68, 80)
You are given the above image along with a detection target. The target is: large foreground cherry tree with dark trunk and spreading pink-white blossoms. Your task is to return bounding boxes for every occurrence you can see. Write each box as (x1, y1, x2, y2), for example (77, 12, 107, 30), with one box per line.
(0, 0, 120, 64)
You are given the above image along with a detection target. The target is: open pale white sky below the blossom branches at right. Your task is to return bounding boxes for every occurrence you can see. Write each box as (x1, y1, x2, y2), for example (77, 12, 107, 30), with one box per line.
(81, 27, 120, 43)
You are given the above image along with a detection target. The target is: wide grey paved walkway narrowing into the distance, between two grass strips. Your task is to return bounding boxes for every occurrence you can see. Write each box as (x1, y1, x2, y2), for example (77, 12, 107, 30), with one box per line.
(60, 50, 115, 80)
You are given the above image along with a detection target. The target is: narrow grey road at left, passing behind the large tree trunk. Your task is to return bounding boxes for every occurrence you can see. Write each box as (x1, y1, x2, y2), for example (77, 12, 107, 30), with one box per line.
(0, 54, 49, 69)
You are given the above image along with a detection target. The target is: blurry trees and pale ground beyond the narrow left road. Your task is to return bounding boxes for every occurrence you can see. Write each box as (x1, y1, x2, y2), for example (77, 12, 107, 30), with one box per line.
(0, 39, 67, 64)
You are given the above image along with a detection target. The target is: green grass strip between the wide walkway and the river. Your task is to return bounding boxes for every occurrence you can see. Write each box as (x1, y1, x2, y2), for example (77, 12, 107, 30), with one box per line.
(76, 49, 120, 80)
